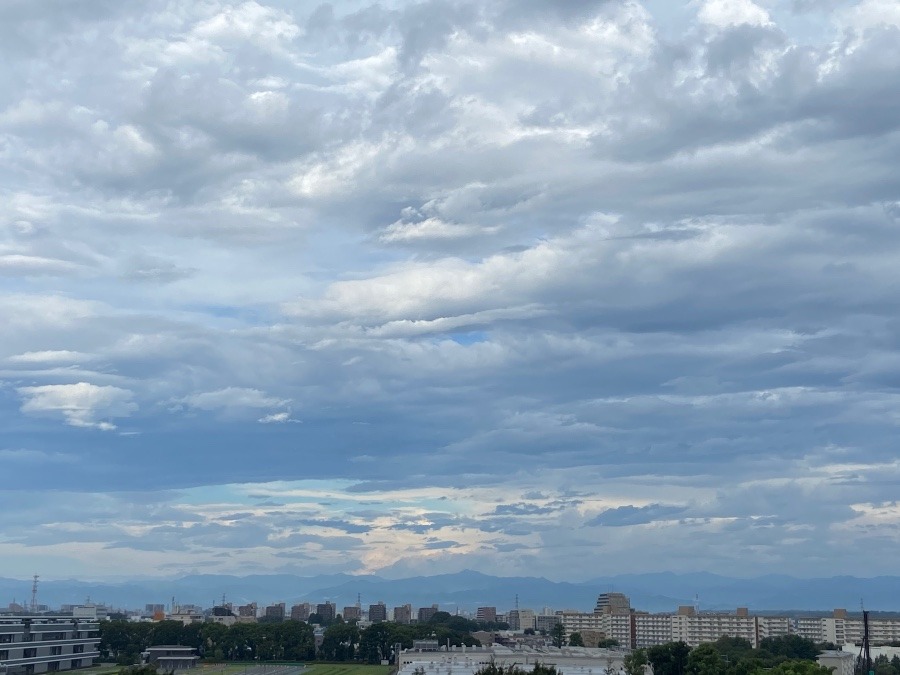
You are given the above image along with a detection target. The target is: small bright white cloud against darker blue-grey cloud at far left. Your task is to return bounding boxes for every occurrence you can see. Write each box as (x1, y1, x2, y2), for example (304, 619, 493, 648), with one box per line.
(16, 382, 137, 431)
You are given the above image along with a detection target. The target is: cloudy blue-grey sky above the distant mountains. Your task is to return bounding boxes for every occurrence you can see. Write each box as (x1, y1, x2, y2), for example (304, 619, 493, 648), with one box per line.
(0, 0, 900, 581)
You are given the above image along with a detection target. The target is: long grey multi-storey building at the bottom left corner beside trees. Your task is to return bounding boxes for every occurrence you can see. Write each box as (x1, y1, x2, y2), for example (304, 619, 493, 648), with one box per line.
(0, 616, 100, 675)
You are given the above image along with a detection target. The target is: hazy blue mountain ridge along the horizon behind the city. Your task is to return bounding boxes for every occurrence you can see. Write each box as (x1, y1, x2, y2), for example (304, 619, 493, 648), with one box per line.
(0, 570, 900, 612)
